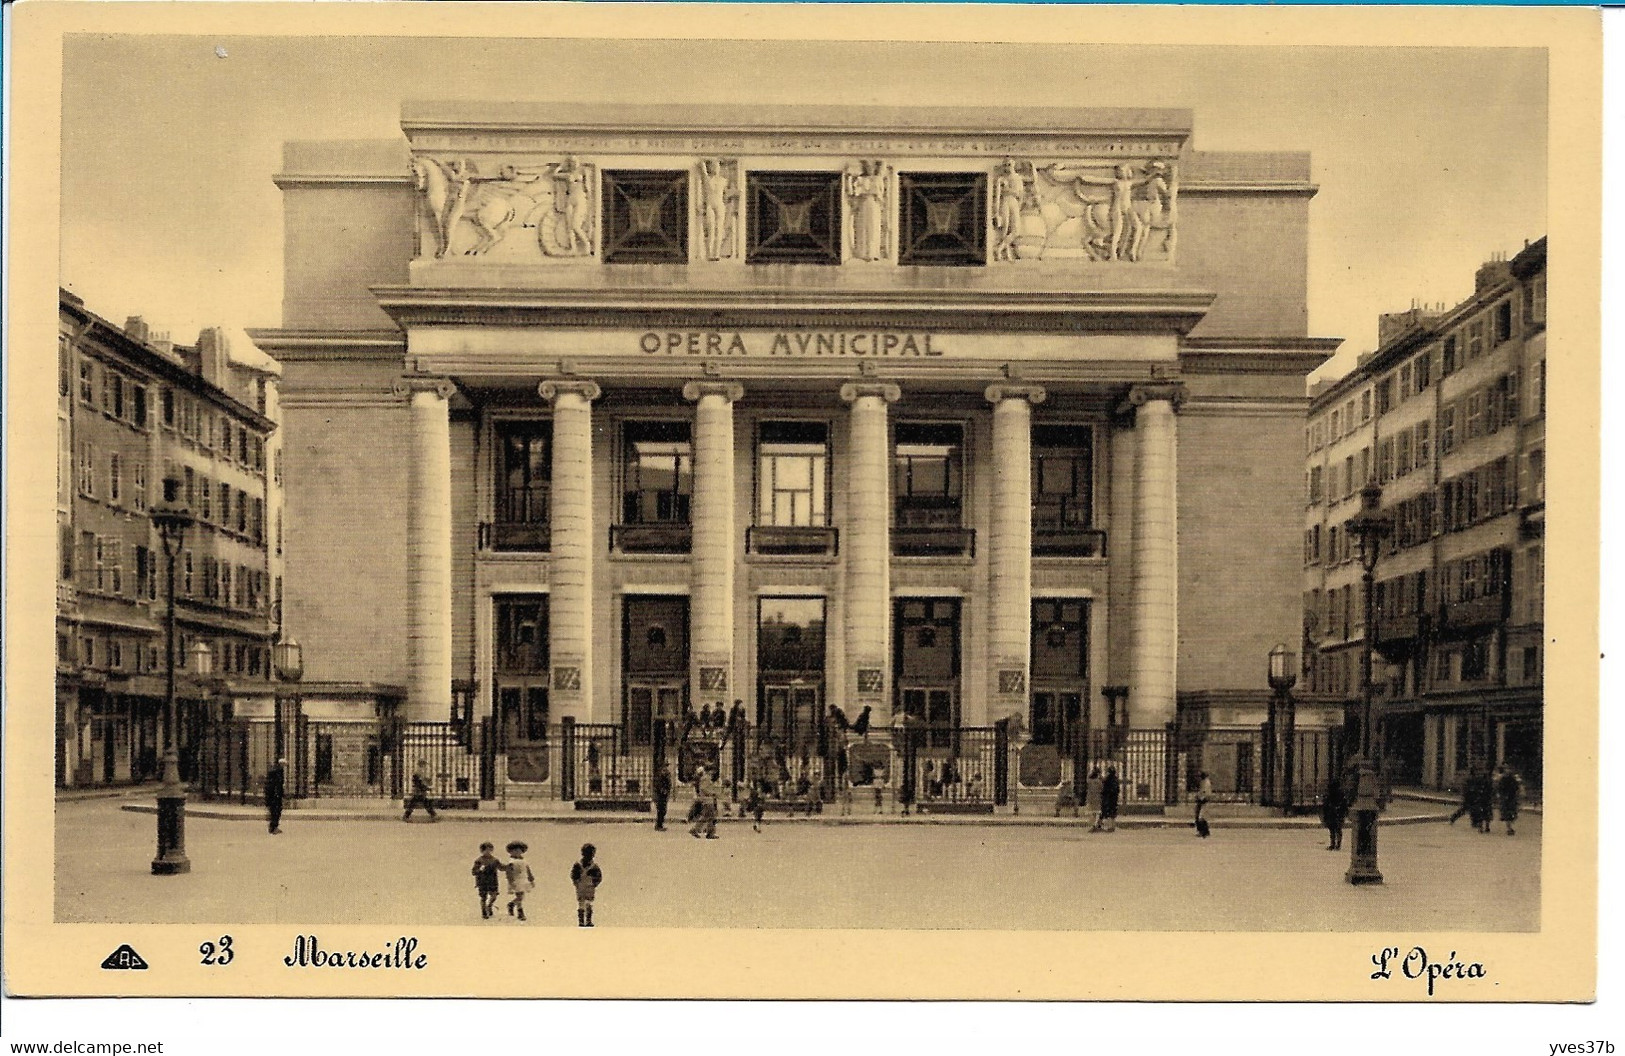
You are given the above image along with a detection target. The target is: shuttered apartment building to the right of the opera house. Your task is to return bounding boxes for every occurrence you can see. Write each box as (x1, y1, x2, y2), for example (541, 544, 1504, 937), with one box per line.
(1303, 239, 1545, 788)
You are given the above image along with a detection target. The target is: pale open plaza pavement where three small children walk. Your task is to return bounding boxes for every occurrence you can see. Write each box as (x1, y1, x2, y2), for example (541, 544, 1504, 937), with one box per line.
(55, 796, 1541, 931)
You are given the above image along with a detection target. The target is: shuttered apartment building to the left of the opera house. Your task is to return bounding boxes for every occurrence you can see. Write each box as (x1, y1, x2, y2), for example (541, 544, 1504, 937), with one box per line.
(55, 291, 283, 786)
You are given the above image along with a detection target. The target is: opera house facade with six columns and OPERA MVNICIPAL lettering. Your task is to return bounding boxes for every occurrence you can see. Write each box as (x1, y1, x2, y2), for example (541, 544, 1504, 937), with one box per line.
(254, 104, 1337, 799)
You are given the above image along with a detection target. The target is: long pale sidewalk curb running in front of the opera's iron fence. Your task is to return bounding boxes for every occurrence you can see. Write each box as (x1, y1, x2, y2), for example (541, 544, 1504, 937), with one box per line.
(120, 803, 1450, 832)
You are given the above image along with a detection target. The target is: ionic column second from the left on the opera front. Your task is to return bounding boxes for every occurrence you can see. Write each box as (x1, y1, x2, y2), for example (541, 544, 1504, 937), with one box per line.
(536, 379, 601, 721)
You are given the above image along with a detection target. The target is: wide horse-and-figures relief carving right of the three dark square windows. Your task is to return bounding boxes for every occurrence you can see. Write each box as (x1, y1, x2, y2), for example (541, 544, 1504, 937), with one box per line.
(993, 159, 1180, 262)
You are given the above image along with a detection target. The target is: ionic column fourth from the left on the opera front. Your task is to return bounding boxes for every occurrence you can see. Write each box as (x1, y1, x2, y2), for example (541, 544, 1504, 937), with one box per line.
(835, 382, 902, 726)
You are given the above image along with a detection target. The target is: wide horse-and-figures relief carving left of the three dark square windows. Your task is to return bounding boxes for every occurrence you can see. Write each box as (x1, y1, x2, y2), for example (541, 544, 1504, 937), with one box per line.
(413, 156, 598, 260)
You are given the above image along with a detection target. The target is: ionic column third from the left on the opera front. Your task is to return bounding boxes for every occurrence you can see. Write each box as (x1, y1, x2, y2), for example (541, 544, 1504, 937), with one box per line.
(683, 382, 744, 710)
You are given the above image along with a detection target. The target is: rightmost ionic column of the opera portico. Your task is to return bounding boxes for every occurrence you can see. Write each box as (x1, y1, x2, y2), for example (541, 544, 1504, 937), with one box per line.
(1128, 383, 1185, 729)
